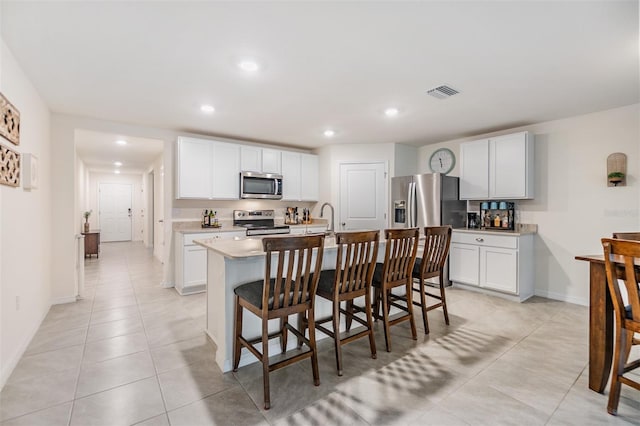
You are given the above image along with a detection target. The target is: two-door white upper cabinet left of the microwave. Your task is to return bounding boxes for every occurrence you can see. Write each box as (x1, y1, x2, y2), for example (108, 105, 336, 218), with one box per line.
(176, 137, 240, 200)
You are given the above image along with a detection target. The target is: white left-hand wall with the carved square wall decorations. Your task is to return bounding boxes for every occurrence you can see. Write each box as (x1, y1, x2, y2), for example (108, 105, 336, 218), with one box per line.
(0, 40, 52, 386)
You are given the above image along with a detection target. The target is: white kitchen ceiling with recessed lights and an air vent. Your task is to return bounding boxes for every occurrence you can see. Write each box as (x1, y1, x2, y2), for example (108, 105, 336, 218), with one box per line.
(0, 0, 640, 157)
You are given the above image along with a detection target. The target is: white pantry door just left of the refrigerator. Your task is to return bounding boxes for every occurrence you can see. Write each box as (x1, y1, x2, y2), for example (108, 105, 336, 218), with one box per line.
(336, 163, 387, 231)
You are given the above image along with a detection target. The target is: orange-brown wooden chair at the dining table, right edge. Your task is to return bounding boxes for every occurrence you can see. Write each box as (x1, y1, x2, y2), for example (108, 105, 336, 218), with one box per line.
(602, 238, 640, 415)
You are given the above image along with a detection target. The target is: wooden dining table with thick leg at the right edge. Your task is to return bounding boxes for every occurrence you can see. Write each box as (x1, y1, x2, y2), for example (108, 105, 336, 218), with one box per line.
(575, 254, 640, 393)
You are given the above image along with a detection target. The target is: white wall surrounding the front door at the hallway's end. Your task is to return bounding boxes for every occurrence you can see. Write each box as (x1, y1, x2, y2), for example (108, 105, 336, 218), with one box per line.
(86, 171, 144, 241)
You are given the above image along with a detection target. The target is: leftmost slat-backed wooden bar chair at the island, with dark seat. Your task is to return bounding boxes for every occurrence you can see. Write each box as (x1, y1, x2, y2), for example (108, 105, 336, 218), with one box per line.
(233, 235, 324, 410)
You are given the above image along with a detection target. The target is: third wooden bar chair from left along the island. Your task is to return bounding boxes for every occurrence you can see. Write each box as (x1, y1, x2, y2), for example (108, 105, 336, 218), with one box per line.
(372, 228, 420, 352)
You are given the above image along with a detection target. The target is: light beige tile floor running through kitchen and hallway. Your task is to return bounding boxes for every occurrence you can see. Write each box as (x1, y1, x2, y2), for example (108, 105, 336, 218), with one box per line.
(0, 243, 640, 426)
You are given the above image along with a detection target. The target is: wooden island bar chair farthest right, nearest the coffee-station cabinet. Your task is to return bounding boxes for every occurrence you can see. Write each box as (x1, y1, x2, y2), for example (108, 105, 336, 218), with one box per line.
(413, 226, 451, 334)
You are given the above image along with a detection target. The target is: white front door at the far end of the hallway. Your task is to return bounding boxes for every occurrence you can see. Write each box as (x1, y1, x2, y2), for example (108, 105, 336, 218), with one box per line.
(100, 183, 132, 242)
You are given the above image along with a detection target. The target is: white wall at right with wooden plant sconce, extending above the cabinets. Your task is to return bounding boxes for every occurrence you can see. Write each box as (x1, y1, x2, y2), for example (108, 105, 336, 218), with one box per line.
(419, 104, 640, 305)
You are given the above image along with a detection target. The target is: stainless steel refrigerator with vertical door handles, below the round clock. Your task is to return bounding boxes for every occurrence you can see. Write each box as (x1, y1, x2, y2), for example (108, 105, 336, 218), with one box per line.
(391, 173, 467, 228)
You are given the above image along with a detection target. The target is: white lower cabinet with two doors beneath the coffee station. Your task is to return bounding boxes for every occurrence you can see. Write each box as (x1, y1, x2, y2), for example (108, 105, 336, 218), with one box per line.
(449, 230, 534, 301)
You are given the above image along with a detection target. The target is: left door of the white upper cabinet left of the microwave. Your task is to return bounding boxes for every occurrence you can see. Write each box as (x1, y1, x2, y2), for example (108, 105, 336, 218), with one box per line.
(176, 137, 213, 198)
